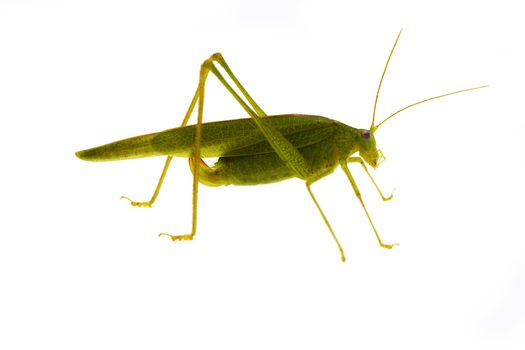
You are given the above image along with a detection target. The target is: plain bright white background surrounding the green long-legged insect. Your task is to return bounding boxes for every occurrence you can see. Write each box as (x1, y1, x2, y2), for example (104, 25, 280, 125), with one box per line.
(0, 0, 525, 349)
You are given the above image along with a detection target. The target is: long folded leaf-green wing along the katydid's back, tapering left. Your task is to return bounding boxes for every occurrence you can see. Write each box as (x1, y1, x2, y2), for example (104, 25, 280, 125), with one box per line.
(76, 114, 337, 161)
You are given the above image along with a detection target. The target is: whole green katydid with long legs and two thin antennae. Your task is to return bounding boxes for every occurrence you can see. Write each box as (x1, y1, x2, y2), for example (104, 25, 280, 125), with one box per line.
(76, 31, 485, 261)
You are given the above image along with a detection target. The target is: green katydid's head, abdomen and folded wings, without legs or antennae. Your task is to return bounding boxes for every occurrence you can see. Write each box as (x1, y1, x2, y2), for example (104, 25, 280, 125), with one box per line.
(77, 114, 375, 186)
